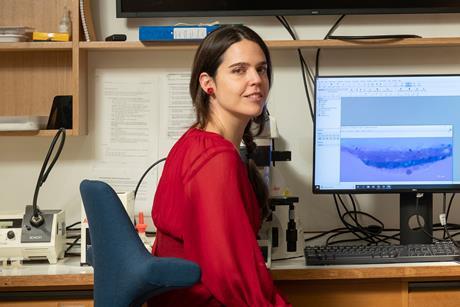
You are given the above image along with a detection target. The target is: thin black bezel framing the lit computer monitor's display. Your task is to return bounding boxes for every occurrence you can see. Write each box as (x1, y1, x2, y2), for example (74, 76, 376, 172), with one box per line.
(312, 74, 460, 194)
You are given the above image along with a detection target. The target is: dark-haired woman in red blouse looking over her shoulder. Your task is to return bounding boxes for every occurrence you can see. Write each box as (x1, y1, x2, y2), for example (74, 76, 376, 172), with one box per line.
(152, 25, 289, 307)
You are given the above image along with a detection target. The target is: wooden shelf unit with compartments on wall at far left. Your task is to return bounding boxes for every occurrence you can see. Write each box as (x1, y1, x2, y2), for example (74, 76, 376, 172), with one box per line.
(0, 0, 88, 137)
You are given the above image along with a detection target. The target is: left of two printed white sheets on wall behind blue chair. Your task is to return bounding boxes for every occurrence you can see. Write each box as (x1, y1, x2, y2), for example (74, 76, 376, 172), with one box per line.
(93, 70, 160, 216)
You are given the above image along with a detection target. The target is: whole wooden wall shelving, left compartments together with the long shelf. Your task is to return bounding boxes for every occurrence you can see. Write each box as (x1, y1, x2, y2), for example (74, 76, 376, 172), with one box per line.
(0, 0, 460, 137)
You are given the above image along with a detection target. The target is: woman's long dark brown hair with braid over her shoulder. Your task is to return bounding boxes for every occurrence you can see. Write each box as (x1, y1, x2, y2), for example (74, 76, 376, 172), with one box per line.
(189, 25, 272, 218)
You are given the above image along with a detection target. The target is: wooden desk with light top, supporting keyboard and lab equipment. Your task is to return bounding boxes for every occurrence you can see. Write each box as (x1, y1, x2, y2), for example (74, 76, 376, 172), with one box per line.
(0, 258, 460, 307)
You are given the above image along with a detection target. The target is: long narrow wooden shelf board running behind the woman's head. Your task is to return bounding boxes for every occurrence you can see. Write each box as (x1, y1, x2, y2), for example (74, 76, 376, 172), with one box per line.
(79, 37, 460, 51)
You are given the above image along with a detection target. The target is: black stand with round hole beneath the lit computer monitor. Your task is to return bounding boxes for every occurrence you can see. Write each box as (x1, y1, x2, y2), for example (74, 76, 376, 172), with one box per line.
(399, 192, 433, 245)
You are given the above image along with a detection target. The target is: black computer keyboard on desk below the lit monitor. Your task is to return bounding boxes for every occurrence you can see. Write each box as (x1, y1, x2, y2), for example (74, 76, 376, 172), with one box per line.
(305, 242, 460, 265)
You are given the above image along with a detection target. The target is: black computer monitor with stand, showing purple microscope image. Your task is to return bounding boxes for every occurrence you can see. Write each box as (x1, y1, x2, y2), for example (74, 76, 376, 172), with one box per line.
(313, 75, 460, 244)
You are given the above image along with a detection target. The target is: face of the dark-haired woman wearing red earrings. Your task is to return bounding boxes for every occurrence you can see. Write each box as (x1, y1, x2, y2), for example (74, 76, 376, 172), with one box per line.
(205, 40, 269, 120)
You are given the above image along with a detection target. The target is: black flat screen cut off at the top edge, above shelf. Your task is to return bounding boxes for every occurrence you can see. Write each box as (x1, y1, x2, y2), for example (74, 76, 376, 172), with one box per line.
(117, 0, 460, 18)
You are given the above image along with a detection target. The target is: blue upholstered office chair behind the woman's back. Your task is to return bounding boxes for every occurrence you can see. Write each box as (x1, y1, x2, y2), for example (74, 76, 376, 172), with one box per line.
(80, 180, 201, 307)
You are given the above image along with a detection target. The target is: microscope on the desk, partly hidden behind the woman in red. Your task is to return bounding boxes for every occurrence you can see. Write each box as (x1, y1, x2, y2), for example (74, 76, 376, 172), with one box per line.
(253, 116, 304, 266)
